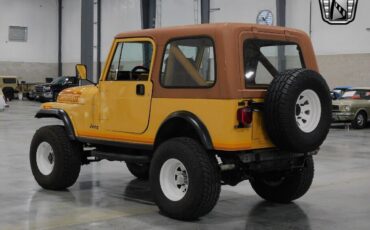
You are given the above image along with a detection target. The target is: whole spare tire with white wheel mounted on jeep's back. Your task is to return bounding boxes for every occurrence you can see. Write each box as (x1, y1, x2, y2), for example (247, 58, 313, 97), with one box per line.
(264, 69, 331, 152)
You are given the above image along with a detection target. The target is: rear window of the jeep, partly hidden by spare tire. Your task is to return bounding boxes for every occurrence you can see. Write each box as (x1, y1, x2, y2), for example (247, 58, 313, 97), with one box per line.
(243, 39, 305, 87)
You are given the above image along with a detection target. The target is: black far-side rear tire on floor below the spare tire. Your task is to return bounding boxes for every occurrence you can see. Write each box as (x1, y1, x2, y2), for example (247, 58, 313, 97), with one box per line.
(250, 156, 314, 203)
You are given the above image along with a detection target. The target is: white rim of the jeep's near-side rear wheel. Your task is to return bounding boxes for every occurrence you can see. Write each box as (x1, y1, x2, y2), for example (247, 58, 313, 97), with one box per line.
(159, 158, 189, 201)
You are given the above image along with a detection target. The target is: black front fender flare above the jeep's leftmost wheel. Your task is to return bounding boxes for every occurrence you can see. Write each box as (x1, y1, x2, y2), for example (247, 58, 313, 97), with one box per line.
(35, 109, 76, 140)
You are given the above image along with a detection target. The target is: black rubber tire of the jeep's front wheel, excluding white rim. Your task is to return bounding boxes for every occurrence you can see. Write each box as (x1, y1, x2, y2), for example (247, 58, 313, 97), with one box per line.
(30, 125, 83, 190)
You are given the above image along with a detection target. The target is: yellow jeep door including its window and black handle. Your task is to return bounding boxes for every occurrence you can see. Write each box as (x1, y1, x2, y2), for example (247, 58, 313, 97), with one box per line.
(99, 38, 154, 133)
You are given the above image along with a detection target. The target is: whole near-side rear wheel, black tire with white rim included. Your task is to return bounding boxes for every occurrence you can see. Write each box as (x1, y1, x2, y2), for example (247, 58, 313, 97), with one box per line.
(150, 137, 221, 220)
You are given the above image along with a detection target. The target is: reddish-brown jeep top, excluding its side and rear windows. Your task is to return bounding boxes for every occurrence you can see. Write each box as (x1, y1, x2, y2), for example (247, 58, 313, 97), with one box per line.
(116, 23, 318, 99)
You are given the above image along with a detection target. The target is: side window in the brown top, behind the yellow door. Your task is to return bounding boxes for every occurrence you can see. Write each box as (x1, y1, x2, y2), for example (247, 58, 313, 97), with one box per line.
(160, 37, 216, 88)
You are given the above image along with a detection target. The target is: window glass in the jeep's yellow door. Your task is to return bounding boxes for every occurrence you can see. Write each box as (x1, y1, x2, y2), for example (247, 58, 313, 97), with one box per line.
(106, 42, 153, 81)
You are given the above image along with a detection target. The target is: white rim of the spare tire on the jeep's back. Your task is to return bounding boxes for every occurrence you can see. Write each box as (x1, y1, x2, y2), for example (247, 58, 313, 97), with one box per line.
(295, 89, 321, 133)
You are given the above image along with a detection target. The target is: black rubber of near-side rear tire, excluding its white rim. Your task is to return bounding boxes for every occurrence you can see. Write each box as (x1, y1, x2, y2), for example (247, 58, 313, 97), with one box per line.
(149, 137, 221, 220)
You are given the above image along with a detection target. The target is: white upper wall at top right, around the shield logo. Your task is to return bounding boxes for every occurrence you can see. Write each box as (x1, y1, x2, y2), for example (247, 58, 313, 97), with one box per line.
(287, 0, 370, 55)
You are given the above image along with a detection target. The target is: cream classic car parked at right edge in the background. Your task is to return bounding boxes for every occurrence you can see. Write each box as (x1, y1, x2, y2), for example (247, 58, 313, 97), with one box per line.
(332, 87, 370, 129)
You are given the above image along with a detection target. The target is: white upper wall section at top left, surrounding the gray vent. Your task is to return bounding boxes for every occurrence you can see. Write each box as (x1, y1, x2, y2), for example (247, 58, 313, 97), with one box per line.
(0, 0, 58, 63)
